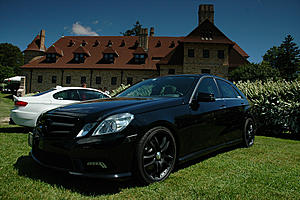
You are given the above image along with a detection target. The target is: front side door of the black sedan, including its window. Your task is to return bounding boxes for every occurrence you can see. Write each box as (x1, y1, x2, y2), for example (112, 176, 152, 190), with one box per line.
(186, 78, 225, 153)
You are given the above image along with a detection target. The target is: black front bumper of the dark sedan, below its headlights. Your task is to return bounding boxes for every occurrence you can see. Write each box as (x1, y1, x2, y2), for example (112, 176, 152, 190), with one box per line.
(28, 131, 137, 179)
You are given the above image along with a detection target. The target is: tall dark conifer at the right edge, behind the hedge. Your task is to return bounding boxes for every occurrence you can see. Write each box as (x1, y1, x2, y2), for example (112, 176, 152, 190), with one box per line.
(263, 35, 300, 80)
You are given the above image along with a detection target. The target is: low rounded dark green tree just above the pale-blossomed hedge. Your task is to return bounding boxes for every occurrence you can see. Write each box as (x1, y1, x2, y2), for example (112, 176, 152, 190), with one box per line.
(229, 62, 279, 81)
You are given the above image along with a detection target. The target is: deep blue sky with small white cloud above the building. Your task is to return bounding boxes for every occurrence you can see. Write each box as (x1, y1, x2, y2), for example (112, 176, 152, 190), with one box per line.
(0, 0, 300, 63)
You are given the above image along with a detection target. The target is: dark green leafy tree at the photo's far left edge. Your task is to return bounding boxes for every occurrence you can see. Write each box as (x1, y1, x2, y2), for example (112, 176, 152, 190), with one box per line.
(0, 43, 24, 82)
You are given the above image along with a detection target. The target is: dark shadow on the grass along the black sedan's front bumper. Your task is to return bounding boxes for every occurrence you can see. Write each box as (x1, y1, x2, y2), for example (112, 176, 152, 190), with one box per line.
(14, 156, 142, 196)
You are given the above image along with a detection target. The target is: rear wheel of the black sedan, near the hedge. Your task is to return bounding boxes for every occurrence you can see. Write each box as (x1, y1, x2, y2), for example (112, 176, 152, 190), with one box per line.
(243, 118, 256, 147)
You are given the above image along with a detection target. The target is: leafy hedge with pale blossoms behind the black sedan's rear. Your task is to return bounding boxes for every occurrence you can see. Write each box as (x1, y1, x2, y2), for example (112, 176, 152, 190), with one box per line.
(236, 80, 300, 137)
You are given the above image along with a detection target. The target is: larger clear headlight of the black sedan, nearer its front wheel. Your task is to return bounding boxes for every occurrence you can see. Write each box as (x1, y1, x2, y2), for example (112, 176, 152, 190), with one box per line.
(92, 113, 134, 136)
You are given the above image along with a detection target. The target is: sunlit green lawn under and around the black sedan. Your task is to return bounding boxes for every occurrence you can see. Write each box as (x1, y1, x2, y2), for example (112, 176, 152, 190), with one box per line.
(0, 93, 300, 199)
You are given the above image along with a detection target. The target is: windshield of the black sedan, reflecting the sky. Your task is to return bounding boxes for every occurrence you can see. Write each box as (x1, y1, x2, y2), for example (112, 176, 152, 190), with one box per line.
(118, 76, 196, 97)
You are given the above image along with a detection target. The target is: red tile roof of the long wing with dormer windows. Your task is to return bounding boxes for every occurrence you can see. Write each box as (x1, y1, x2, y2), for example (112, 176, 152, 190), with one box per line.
(21, 36, 183, 70)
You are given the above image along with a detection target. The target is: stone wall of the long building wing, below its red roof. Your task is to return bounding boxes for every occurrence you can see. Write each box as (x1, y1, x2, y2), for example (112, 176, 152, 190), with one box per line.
(22, 69, 159, 93)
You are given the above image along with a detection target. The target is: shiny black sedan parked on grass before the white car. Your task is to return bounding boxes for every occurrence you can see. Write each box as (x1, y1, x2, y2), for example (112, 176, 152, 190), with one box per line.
(29, 75, 255, 183)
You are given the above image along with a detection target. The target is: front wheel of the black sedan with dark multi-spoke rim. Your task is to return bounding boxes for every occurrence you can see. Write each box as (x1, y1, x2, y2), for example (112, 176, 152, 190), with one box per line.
(137, 126, 176, 184)
